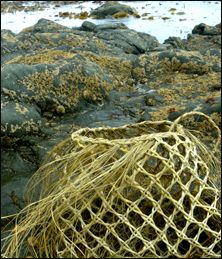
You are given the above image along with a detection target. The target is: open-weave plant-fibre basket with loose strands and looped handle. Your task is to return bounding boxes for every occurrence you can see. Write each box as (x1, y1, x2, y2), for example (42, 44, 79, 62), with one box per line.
(2, 112, 221, 258)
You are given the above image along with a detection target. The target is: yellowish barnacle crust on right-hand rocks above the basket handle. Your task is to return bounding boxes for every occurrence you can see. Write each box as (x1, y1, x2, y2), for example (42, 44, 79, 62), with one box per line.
(132, 51, 221, 125)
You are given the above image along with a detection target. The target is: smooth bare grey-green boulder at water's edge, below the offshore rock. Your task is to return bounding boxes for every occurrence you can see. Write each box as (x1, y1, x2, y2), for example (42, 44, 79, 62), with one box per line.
(96, 29, 159, 54)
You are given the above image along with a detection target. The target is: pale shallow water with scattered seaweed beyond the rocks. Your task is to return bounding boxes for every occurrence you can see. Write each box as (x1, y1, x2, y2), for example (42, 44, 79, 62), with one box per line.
(1, 1, 221, 43)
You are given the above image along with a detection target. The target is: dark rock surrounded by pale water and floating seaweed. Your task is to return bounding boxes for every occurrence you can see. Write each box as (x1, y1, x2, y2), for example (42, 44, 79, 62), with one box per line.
(90, 1, 137, 19)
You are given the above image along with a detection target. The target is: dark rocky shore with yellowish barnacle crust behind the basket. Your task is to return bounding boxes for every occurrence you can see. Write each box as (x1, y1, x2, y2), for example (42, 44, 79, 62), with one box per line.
(1, 1, 221, 223)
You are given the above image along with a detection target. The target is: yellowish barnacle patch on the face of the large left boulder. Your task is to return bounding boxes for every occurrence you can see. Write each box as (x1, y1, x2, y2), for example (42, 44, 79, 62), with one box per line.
(22, 69, 110, 109)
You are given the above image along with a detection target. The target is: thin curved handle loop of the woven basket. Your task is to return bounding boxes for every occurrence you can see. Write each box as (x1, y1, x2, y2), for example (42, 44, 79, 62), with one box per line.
(169, 111, 221, 157)
